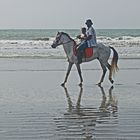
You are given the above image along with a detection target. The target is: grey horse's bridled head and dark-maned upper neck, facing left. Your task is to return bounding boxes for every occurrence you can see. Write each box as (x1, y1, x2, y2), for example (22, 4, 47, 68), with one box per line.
(51, 32, 74, 48)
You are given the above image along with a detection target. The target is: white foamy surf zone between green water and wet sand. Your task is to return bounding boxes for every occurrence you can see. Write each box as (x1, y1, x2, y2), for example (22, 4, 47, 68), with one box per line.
(0, 36, 140, 58)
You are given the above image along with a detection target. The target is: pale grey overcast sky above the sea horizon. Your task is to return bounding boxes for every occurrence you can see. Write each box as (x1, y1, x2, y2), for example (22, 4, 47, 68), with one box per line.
(0, 0, 140, 29)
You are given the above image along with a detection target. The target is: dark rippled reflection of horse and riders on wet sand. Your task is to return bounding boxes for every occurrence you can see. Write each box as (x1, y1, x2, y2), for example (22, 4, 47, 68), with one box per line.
(55, 87, 118, 140)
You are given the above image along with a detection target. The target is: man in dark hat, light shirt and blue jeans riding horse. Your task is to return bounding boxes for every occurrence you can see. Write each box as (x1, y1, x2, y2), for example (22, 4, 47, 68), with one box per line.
(77, 19, 97, 64)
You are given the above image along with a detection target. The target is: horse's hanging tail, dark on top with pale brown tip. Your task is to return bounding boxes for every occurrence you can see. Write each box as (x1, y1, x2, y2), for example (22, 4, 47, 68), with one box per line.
(110, 47, 119, 74)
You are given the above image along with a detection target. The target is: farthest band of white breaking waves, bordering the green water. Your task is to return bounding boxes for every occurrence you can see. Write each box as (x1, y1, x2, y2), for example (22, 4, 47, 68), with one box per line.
(0, 36, 140, 47)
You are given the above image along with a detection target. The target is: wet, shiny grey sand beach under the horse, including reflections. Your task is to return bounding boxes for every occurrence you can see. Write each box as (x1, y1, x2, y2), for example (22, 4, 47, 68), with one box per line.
(0, 58, 140, 140)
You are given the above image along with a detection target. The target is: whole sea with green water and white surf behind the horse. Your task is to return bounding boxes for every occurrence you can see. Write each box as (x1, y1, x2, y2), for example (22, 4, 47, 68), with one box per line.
(0, 29, 140, 59)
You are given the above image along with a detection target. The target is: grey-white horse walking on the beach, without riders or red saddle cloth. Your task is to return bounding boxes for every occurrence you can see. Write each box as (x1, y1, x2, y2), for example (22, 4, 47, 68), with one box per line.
(52, 32, 118, 86)
